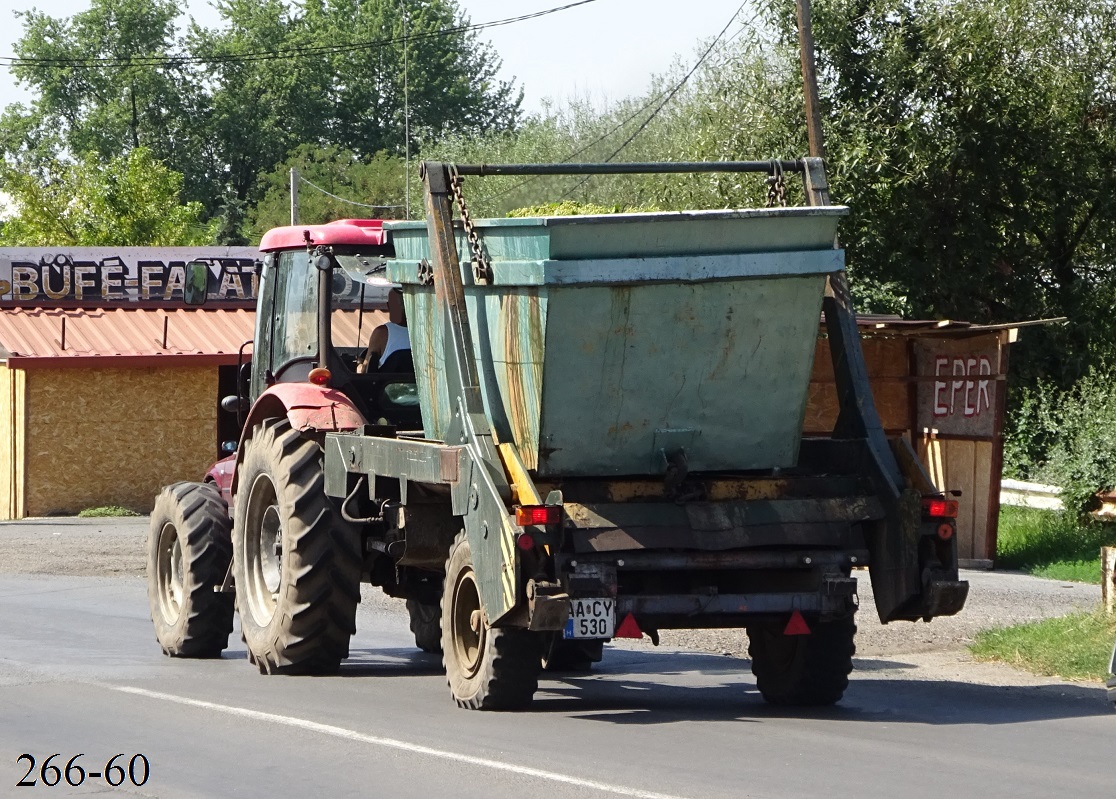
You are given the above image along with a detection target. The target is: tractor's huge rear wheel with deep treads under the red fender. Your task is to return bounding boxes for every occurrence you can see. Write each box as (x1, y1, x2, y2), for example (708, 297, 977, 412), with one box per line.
(232, 418, 360, 674)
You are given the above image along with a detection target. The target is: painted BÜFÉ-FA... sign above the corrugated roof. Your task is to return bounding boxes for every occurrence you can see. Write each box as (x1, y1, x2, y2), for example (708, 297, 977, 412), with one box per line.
(0, 247, 259, 307)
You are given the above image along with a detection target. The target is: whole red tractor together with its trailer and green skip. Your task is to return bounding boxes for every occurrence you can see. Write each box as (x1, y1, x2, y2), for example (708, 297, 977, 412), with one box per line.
(148, 158, 968, 710)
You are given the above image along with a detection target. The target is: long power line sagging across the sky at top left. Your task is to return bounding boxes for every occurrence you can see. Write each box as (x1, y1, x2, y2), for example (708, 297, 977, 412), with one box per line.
(0, 0, 597, 68)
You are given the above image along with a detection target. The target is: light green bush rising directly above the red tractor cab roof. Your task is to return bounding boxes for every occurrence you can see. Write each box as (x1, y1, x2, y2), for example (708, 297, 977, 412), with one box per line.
(248, 145, 410, 241)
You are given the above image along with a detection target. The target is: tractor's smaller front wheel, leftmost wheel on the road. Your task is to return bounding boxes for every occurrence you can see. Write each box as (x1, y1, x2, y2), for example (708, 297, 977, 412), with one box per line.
(147, 483, 232, 657)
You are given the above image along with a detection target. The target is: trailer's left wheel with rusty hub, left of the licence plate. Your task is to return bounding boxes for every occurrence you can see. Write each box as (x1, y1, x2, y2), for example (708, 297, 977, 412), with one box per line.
(442, 531, 541, 710)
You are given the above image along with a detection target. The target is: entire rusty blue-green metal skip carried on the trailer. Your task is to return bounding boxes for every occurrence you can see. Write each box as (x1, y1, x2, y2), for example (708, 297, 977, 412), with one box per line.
(388, 208, 845, 478)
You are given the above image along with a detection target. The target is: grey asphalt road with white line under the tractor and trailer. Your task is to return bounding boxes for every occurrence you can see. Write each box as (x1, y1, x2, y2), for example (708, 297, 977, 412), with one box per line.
(0, 564, 1116, 799)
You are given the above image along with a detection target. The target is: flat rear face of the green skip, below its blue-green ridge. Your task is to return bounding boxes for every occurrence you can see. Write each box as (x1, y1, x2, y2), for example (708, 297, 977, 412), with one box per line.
(538, 275, 825, 476)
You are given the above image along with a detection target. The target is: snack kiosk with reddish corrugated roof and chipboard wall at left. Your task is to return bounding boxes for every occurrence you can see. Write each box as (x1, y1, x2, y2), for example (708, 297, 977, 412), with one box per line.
(0, 308, 254, 519)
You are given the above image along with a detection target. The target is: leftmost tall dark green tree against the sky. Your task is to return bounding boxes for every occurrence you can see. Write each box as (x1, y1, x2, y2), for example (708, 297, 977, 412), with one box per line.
(0, 0, 213, 206)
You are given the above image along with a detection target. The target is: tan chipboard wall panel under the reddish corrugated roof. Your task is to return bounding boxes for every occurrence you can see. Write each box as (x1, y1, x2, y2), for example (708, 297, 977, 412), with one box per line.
(27, 367, 218, 516)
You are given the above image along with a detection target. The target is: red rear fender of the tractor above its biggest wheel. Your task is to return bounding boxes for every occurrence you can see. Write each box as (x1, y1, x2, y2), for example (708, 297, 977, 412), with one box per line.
(230, 383, 366, 495)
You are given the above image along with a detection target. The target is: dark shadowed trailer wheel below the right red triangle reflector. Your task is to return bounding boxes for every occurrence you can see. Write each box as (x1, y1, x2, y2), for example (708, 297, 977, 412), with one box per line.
(748, 616, 856, 705)
